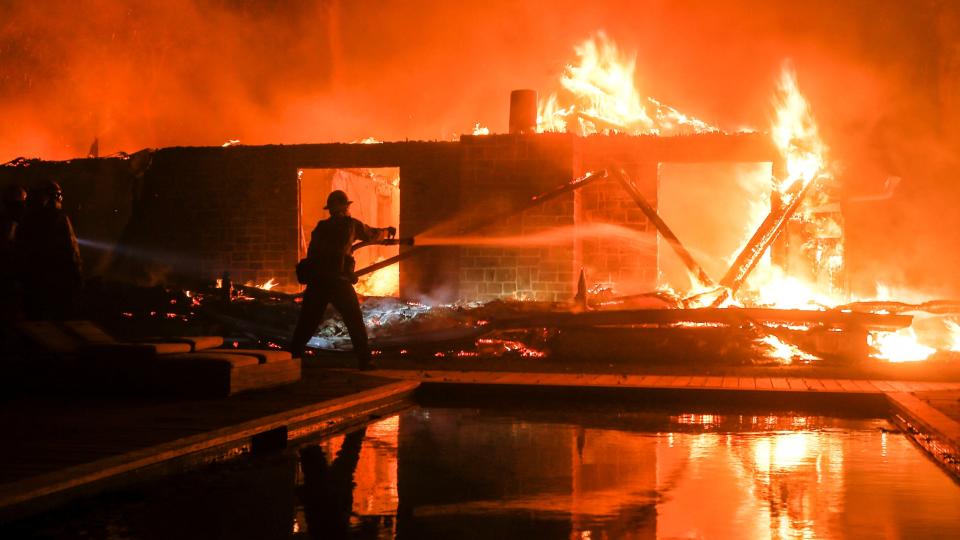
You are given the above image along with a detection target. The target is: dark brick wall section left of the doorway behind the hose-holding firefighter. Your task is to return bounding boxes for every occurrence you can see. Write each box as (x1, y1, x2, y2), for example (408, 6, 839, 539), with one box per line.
(121, 143, 298, 285)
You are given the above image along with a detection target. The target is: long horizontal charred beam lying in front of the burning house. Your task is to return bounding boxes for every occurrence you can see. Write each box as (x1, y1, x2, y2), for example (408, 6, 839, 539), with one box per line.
(489, 308, 913, 331)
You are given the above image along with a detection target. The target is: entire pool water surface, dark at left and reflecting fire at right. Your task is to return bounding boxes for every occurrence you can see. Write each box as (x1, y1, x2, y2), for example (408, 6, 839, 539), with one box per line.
(4, 407, 960, 540)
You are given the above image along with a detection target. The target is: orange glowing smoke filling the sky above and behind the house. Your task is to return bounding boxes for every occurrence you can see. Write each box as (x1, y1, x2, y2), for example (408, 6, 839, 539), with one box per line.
(0, 0, 960, 292)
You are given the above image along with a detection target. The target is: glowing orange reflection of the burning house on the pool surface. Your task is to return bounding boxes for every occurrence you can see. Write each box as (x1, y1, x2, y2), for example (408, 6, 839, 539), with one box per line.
(304, 409, 960, 539)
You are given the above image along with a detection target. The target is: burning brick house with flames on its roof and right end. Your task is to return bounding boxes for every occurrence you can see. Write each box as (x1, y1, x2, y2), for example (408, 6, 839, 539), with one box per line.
(0, 33, 952, 364)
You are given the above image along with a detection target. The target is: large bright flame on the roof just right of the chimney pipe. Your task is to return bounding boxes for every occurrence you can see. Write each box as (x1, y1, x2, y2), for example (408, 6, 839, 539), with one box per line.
(537, 32, 719, 135)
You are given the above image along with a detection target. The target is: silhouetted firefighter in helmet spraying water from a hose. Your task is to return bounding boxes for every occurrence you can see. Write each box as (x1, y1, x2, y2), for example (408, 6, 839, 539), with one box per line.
(290, 190, 397, 370)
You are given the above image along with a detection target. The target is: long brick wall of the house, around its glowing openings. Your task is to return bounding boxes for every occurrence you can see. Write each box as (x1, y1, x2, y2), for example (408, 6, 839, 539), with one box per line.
(0, 134, 775, 301)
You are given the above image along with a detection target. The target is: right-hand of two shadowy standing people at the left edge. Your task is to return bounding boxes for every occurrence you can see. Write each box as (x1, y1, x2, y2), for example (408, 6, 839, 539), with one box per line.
(14, 180, 83, 320)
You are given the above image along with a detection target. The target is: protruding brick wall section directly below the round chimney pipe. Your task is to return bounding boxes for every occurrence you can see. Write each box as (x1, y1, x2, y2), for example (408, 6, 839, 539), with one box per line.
(458, 134, 576, 301)
